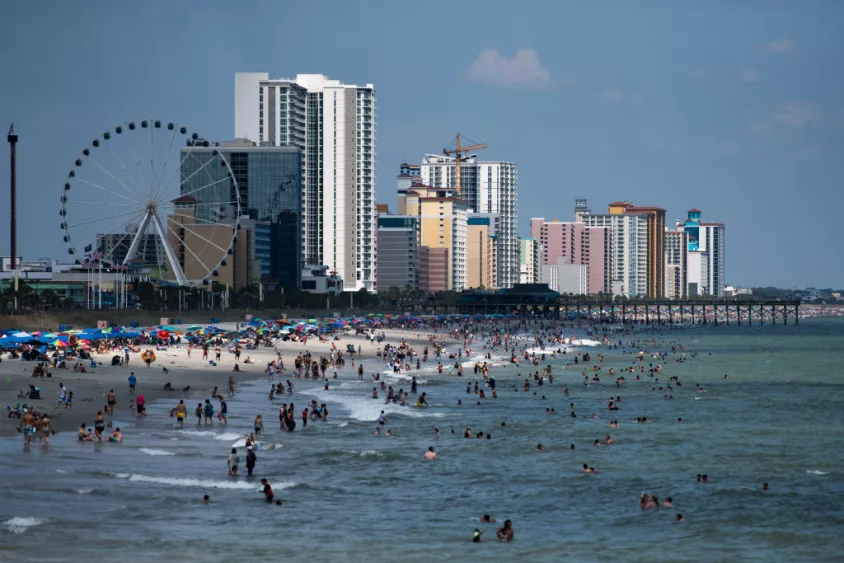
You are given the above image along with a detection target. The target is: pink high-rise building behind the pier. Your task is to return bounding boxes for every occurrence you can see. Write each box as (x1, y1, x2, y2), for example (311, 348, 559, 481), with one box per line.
(530, 217, 612, 294)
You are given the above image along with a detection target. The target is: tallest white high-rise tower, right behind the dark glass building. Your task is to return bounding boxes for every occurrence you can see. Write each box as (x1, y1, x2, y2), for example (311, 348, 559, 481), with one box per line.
(235, 72, 378, 291)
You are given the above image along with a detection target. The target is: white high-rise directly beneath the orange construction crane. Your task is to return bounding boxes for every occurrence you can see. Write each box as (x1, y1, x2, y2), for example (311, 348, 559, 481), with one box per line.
(421, 154, 521, 288)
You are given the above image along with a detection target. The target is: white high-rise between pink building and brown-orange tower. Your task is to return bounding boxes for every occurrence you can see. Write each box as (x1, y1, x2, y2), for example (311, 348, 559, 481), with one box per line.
(577, 213, 648, 297)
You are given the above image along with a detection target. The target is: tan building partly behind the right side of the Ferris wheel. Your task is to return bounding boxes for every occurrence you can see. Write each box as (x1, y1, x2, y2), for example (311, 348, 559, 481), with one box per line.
(167, 196, 261, 289)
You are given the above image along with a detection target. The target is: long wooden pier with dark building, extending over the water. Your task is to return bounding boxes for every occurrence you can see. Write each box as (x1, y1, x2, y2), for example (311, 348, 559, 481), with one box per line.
(448, 284, 800, 326)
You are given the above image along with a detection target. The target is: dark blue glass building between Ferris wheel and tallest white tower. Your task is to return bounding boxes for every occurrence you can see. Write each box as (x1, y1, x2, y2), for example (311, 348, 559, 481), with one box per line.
(176, 139, 302, 287)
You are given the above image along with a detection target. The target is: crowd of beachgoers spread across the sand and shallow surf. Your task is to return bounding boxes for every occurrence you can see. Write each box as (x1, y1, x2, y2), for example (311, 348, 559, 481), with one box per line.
(1, 316, 784, 542)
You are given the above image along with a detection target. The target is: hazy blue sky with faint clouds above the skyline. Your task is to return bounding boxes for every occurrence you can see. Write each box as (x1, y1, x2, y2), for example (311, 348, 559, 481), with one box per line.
(0, 0, 844, 288)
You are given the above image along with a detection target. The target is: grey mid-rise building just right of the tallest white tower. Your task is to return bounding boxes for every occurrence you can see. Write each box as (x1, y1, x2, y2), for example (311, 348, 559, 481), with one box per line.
(378, 215, 419, 291)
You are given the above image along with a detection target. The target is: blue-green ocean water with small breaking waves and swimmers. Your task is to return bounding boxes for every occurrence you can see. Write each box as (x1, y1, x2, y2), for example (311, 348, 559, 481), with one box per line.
(0, 318, 844, 562)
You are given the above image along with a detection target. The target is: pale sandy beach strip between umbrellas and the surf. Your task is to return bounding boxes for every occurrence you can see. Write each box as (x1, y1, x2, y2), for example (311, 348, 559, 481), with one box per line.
(0, 323, 458, 437)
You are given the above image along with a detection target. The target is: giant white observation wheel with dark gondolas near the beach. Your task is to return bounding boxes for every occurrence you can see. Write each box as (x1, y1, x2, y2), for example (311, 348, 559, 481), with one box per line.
(60, 119, 241, 286)
